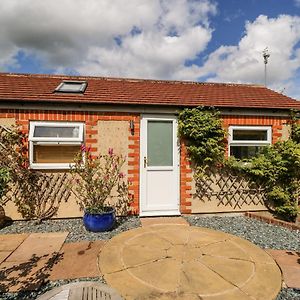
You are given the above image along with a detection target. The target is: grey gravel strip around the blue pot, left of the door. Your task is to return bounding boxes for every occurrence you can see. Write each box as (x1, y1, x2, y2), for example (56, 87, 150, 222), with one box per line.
(0, 217, 141, 243)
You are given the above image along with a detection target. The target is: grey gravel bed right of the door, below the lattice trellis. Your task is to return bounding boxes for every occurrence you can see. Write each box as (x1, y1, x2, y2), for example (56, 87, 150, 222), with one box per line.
(185, 216, 300, 251)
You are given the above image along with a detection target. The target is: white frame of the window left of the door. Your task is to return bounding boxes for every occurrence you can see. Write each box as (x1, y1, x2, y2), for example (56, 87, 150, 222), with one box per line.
(28, 121, 84, 170)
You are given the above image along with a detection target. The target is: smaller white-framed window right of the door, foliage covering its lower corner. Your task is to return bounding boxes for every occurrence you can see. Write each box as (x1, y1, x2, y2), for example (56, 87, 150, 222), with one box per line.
(228, 126, 272, 159)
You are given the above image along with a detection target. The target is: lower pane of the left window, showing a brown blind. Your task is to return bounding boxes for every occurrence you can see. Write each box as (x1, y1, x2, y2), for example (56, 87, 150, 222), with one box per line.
(33, 145, 80, 163)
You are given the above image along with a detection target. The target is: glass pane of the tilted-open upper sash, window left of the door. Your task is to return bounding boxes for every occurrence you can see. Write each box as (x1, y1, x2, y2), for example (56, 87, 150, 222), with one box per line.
(33, 126, 79, 138)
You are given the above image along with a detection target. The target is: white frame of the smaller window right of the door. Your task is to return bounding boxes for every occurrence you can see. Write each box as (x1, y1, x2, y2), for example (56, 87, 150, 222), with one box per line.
(228, 125, 272, 156)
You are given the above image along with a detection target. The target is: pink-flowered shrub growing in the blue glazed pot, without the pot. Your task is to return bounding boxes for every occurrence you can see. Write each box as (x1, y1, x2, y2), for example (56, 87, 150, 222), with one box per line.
(70, 146, 131, 214)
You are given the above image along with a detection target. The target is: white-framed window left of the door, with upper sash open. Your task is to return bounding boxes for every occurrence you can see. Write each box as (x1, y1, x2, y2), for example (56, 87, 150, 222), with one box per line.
(29, 122, 83, 169)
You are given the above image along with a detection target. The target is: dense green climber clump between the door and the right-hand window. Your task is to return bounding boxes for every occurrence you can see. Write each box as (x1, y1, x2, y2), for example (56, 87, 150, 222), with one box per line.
(178, 107, 225, 169)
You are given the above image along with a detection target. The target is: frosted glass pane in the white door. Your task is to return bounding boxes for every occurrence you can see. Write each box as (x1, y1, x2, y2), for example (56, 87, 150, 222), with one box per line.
(147, 121, 173, 166)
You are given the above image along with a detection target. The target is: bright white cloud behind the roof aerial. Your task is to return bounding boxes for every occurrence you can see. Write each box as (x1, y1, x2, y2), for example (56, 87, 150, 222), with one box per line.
(183, 15, 300, 98)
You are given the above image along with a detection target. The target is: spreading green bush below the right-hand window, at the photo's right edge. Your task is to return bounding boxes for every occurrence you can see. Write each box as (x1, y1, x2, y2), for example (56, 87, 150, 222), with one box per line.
(228, 140, 300, 221)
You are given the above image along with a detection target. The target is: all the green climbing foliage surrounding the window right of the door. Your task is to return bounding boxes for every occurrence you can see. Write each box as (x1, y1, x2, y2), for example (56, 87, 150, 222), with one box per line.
(178, 107, 300, 221)
